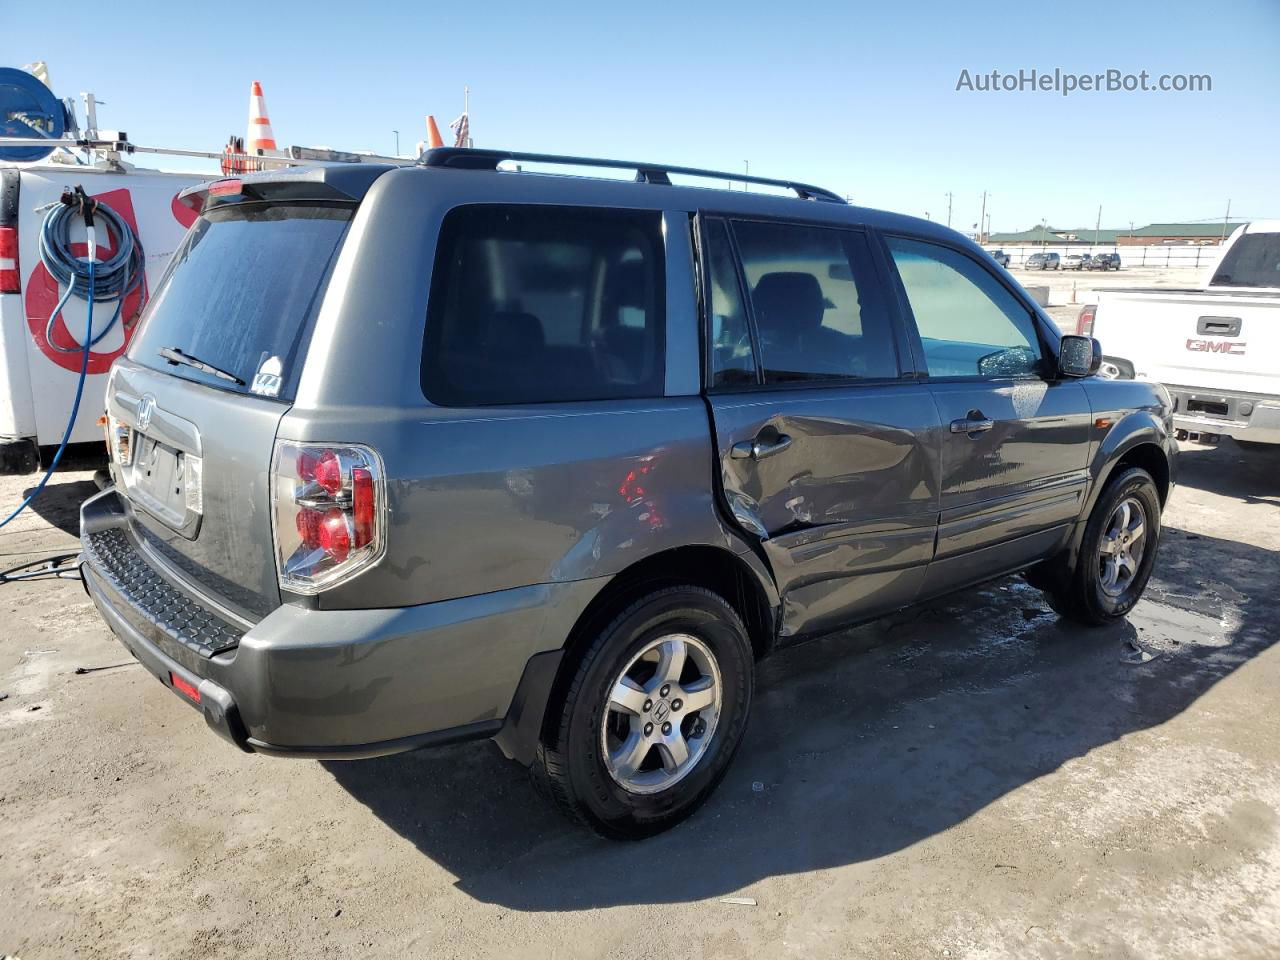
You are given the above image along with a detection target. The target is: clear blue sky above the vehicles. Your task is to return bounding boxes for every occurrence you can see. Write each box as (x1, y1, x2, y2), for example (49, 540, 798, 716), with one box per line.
(0, 0, 1280, 230)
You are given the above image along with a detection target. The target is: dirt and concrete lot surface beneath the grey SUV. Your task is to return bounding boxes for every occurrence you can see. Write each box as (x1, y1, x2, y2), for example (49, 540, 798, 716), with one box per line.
(0, 440, 1280, 960)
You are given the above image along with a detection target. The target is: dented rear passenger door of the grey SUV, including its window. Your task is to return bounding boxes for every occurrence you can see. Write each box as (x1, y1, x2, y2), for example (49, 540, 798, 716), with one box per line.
(701, 218, 940, 635)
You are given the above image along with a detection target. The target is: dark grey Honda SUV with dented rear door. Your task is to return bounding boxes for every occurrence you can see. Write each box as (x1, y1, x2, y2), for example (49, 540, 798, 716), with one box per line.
(81, 148, 1176, 837)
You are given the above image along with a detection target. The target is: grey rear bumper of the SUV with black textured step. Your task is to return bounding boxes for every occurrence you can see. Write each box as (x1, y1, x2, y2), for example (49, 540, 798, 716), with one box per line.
(81, 490, 602, 759)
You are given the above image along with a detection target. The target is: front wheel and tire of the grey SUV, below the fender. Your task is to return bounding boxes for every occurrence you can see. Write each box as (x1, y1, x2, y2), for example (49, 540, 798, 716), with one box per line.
(1036, 467, 1160, 626)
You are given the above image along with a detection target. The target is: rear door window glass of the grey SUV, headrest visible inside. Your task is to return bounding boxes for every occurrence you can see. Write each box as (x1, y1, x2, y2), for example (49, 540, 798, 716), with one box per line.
(733, 220, 899, 383)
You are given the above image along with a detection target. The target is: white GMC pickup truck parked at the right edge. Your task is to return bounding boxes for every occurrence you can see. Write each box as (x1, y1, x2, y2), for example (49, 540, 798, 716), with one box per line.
(1076, 220, 1280, 451)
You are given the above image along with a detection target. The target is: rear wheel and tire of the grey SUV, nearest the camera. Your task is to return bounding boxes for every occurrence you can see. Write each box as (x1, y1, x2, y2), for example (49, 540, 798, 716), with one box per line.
(534, 586, 754, 840)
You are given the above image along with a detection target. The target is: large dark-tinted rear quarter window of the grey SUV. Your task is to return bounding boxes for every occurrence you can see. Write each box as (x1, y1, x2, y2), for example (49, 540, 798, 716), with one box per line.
(422, 205, 666, 406)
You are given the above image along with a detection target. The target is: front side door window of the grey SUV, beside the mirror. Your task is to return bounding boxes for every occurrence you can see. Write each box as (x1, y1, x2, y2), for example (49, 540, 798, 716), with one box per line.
(888, 237, 1041, 376)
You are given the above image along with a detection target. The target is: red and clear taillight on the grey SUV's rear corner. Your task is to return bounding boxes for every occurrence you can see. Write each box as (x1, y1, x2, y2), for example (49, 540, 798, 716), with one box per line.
(271, 440, 387, 594)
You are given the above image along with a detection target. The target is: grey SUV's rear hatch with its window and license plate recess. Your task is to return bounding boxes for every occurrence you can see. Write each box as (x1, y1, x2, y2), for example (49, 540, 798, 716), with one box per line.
(108, 166, 387, 622)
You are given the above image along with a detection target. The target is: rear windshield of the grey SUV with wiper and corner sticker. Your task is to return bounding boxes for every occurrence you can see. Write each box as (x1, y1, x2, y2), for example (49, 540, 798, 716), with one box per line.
(129, 202, 355, 401)
